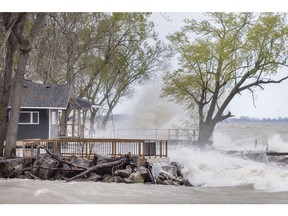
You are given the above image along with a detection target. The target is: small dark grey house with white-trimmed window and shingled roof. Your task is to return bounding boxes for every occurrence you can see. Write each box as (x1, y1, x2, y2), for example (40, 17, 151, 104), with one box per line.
(8, 80, 99, 140)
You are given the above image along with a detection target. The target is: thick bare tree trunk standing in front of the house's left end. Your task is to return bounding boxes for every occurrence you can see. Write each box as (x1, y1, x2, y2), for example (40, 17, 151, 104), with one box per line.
(5, 13, 45, 158)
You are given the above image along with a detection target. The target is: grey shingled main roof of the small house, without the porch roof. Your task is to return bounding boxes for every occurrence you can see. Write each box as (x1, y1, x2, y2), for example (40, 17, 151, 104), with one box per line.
(12, 80, 71, 109)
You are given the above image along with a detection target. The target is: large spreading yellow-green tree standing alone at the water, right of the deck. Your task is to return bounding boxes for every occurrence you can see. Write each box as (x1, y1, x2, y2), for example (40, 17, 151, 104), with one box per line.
(162, 13, 288, 144)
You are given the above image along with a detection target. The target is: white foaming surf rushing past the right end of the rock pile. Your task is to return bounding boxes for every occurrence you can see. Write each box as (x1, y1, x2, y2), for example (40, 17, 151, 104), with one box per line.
(170, 147, 288, 192)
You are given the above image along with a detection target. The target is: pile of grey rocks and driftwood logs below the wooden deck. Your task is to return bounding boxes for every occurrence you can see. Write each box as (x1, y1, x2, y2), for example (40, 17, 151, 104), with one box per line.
(0, 154, 192, 186)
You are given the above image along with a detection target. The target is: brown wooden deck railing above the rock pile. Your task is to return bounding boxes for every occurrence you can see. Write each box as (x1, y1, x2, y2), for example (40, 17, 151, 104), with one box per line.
(23, 138, 168, 159)
